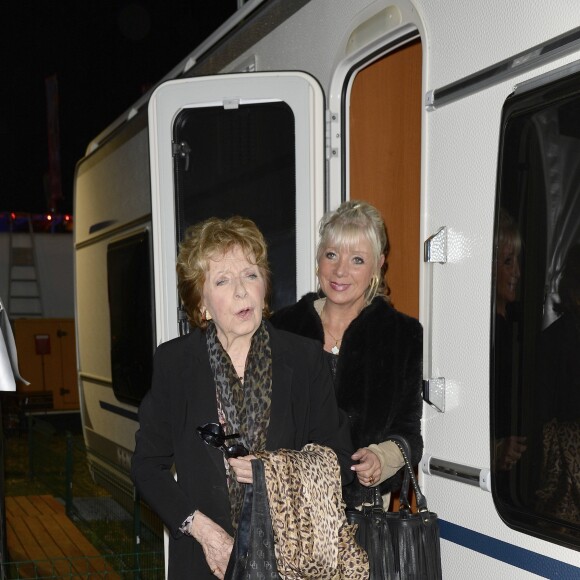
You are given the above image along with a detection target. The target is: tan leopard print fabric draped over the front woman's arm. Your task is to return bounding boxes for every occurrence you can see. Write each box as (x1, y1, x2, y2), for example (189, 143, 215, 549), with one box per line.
(257, 443, 369, 580)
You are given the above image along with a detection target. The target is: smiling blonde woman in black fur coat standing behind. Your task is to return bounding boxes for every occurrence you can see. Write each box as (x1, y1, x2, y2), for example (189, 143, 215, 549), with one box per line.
(271, 201, 423, 506)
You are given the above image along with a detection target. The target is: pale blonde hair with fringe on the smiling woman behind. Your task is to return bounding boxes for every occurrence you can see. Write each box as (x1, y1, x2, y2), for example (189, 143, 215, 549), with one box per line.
(316, 200, 390, 304)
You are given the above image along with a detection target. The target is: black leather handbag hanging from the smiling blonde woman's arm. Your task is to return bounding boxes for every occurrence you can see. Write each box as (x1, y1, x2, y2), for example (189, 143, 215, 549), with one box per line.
(346, 435, 442, 580)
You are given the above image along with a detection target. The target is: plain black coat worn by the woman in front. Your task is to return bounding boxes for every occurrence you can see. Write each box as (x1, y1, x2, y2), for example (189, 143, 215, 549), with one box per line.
(131, 323, 353, 580)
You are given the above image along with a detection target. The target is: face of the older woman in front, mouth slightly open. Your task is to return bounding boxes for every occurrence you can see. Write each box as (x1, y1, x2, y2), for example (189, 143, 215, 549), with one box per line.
(201, 246, 266, 350)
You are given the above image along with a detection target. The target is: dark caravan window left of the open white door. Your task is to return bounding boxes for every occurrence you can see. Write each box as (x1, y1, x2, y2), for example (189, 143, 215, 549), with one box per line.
(107, 231, 155, 405)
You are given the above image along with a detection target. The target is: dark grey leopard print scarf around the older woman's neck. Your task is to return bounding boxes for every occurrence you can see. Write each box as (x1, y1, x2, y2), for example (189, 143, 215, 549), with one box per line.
(206, 321, 272, 528)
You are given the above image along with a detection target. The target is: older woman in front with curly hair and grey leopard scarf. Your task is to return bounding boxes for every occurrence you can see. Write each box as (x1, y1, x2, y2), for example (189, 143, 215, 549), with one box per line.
(132, 217, 352, 580)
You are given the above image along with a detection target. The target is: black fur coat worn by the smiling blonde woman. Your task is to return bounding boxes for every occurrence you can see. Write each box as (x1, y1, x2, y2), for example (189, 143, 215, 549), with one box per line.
(270, 292, 423, 505)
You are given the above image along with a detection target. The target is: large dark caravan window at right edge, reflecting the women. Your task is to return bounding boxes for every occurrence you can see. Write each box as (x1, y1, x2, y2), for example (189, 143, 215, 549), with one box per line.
(490, 67, 580, 548)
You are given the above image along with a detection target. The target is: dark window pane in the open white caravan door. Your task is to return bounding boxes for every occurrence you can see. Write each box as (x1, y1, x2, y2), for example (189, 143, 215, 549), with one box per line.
(173, 102, 296, 309)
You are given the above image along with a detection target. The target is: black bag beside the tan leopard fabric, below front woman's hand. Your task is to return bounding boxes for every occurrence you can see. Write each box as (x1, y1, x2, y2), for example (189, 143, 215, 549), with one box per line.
(224, 459, 280, 580)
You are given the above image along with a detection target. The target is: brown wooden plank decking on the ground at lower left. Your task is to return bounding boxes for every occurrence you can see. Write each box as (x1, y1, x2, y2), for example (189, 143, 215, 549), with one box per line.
(5, 495, 121, 579)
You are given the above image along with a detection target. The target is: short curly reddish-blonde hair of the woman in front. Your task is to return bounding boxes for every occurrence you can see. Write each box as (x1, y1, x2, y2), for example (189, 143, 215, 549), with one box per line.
(176, 216, 270, 328)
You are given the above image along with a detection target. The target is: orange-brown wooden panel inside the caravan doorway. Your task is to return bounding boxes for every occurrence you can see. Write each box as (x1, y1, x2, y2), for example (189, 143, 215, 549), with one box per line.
(349, 40, 422, 318)
